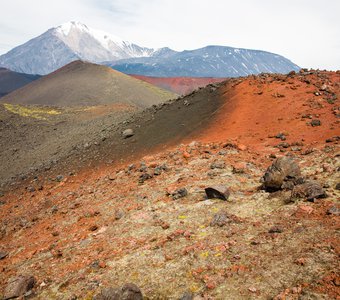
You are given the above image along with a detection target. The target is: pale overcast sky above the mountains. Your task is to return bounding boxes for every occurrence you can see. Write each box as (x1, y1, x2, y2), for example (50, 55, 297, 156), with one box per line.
(0, 0, 340, 70)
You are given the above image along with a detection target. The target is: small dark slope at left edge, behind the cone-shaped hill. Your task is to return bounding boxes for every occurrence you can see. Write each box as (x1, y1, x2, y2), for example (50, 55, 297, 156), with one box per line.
(0, 68, 41, 97)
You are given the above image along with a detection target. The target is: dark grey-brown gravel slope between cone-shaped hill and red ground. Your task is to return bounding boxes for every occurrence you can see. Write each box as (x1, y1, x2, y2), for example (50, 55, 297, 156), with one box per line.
(0, 82, 221, 188)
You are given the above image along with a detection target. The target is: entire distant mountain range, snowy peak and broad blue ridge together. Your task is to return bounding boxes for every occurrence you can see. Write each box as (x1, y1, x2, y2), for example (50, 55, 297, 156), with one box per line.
(0, 22, 300, 77)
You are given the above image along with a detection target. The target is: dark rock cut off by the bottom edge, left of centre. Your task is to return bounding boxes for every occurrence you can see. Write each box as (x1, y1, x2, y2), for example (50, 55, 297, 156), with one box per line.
(93, 283, 143, 300)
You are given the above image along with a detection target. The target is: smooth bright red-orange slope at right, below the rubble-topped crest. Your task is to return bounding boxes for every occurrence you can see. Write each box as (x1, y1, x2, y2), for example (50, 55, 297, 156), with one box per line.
(191, 72, 340, 149)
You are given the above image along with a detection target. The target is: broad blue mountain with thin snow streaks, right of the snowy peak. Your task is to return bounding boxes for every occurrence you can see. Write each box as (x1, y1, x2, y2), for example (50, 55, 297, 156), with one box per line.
(106, 46, 300, 77)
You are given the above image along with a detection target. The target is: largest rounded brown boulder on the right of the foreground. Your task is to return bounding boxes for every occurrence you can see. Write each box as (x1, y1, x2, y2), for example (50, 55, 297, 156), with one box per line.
(261, 156, 301, 192)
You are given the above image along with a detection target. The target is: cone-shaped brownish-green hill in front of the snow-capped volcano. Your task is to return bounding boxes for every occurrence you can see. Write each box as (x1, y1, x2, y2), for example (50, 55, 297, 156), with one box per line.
(1, 61, 174, 108)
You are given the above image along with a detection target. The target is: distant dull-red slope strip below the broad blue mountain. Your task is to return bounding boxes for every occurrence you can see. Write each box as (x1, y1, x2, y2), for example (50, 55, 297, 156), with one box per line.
(131, 75, 226, 95)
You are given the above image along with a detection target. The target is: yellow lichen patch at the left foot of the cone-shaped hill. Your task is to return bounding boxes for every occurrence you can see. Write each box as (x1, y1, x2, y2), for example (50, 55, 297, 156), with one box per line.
(4, 103, 61, 120)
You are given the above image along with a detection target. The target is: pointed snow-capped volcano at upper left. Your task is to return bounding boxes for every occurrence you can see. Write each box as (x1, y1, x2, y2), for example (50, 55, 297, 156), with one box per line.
(0, 22, 154, 74)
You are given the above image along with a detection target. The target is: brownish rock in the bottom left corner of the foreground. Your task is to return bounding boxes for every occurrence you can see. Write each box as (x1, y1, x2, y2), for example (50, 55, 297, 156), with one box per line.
(3, 275, 36, 300)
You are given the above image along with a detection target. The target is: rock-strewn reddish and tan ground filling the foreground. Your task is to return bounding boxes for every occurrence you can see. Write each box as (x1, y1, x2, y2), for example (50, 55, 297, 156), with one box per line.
(0, 137, 340, 300)
